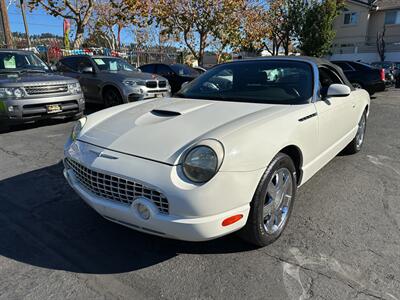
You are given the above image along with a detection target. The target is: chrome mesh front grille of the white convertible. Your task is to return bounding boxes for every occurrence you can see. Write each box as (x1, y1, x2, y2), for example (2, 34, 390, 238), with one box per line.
(65, 158, 169, 214)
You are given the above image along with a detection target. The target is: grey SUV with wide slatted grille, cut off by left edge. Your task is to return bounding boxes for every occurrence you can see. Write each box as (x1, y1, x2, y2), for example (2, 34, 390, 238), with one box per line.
(0, 50, 85, 130)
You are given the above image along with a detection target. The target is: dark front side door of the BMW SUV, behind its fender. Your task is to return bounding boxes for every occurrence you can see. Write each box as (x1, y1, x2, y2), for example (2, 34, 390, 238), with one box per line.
(77, 57, 102, 102)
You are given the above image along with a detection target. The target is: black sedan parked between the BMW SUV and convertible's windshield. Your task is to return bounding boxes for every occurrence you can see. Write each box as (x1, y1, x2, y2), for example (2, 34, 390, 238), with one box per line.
(139, 64, 199, 94)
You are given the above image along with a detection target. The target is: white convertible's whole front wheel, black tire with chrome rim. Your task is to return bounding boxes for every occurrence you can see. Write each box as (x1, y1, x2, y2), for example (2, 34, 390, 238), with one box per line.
(239, 153, 297, 247)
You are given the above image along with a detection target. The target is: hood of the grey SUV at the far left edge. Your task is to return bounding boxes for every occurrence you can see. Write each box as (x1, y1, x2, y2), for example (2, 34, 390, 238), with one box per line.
(0, 73, 76, 86)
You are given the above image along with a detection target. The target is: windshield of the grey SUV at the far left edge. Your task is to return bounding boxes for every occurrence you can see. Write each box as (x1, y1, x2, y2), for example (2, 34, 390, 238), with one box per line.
(0, 52, 49, 73)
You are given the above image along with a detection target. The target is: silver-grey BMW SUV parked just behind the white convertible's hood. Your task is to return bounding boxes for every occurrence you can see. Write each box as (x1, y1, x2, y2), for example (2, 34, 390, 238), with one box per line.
(55, 55, 171, 107)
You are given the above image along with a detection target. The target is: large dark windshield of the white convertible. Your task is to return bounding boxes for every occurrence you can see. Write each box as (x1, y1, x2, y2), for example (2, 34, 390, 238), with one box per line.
(177, 60, 313, 104)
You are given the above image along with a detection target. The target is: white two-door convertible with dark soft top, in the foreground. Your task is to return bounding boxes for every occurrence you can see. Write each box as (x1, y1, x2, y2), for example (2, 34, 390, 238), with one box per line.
(64, 57, 370, 246)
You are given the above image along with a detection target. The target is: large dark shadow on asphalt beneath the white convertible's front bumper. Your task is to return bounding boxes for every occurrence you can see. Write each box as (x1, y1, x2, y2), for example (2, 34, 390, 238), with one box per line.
(0, 162, 254, 274)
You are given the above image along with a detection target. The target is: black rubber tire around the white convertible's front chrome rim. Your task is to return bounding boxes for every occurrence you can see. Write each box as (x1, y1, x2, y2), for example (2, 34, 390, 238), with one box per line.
(239, 153, 297, 247)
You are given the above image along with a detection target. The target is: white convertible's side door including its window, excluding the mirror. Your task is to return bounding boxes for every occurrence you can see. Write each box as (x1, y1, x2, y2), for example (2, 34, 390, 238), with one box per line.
(315, 67, 355, 155)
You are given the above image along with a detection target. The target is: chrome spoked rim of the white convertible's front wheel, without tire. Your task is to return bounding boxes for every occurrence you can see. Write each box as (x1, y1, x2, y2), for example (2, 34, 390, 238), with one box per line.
(263, 168, 293, 234)
